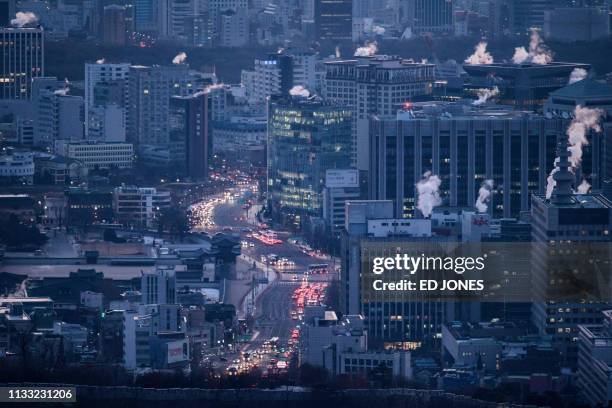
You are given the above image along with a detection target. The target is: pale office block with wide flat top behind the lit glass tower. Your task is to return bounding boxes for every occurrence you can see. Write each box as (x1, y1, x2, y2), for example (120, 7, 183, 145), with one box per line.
(323, 55, 435, 171)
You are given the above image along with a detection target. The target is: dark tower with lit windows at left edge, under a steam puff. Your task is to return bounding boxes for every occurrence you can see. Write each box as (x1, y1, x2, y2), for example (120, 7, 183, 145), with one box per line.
(0, 28, 45, 100)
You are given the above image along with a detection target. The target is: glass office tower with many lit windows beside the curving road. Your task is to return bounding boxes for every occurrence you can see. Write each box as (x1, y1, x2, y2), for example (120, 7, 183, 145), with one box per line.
(268, 98, 352, 226)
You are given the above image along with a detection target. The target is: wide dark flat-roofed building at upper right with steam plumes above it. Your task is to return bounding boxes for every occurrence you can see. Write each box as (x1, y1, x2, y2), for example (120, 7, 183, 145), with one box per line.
(463, 62, 591, 110)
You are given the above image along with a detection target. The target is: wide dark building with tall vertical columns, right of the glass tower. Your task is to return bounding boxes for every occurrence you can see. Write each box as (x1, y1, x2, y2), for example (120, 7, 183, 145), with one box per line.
(369, 103, 610, 218)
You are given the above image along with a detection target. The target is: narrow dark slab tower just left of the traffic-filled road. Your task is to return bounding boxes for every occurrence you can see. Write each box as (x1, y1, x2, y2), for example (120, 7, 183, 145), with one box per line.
(170, 92, 210, 180)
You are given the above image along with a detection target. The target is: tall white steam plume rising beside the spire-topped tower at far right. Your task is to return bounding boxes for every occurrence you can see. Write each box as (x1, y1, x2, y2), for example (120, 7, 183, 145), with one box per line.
(546, 106, 604, 198)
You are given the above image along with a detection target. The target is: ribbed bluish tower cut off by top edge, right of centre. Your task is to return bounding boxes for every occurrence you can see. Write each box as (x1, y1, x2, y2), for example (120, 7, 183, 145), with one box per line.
(402, 0, 454, 33)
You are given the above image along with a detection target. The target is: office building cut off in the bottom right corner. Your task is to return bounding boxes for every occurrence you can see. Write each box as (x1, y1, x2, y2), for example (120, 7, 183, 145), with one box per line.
(578, 310, 612, 407)
